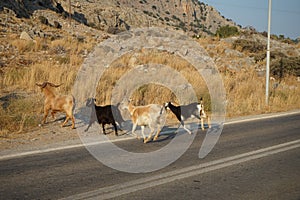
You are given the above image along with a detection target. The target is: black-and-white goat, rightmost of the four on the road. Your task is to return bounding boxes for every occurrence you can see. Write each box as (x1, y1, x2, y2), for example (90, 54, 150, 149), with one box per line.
(165, 98, 210, 134)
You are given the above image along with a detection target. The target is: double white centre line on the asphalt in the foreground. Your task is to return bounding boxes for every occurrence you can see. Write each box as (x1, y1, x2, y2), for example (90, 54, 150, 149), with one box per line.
(64, 140, 300, 200)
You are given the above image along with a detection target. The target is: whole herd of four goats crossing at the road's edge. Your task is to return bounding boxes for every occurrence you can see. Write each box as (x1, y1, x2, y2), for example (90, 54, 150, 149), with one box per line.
(36, 82, 210, 143)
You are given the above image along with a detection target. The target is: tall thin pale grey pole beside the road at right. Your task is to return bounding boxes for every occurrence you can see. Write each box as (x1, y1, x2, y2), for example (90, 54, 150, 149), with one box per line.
(266, 0, 272, 105)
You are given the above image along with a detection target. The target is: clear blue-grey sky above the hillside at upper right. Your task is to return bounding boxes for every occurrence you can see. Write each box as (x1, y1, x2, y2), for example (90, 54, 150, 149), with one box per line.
(200, 0, 300, 39)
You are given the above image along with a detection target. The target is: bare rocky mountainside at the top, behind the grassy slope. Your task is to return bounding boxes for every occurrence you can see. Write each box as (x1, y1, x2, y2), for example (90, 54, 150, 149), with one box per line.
(0, 0, 235, 35)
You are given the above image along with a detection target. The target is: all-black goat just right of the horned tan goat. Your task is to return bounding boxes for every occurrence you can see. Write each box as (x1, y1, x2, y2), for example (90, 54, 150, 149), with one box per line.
(85, 98, 124, 136)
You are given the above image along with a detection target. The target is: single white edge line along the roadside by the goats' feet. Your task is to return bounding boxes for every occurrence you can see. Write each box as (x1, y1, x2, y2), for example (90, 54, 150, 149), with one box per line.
(0, 110, 300, 161)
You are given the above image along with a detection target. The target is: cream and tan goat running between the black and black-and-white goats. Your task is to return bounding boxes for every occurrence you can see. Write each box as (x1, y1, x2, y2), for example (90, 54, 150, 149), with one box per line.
(127, 100, 166, 144)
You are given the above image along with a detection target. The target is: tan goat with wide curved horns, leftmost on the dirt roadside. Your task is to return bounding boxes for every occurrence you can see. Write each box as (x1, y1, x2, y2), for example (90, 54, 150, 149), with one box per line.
(36, 82, 75, 129)
